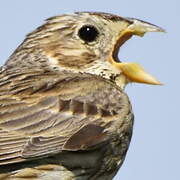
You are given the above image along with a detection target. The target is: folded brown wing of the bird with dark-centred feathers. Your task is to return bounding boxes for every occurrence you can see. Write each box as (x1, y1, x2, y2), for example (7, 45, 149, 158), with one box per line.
(0, 72, 129, 165)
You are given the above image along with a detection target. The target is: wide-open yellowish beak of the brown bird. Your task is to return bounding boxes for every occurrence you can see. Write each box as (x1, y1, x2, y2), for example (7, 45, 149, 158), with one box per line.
(111, 18, 165, 85)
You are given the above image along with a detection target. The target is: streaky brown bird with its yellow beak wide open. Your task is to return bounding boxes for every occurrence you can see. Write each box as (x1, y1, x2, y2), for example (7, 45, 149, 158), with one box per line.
(0, 12, 164, 180)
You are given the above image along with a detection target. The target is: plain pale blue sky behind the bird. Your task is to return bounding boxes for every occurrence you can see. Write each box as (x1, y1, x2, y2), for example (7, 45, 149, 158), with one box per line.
(0, 0, 180, 180)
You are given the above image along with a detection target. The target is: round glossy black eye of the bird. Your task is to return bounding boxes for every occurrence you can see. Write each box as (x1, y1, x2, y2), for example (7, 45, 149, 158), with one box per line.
(78, 25, 99, 43)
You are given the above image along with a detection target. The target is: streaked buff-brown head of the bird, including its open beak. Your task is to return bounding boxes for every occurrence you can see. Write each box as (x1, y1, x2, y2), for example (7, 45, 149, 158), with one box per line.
(7, 12, 164, 88)
